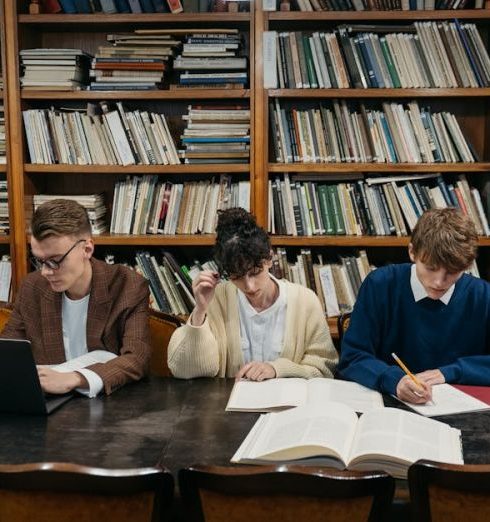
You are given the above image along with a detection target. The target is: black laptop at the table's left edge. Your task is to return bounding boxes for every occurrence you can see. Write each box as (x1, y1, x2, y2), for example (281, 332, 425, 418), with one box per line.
(0, 339, 73, 415)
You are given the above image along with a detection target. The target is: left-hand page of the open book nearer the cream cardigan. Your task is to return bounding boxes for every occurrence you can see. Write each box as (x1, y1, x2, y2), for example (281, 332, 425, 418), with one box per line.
(226, 378, 307, 411)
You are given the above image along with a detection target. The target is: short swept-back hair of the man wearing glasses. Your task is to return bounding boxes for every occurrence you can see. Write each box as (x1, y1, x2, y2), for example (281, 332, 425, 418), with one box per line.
(31, 199, 92, 241)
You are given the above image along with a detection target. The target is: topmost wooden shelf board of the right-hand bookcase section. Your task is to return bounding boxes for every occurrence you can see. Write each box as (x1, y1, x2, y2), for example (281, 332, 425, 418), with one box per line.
(264, 9, 490, 21)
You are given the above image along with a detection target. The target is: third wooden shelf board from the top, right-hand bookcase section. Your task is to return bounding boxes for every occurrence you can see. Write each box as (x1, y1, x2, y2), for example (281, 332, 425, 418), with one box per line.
(268, 162, 490, 174)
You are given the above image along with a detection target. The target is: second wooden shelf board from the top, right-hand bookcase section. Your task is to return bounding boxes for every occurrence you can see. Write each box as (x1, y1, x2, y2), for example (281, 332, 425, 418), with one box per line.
(268, 87, 490, 99)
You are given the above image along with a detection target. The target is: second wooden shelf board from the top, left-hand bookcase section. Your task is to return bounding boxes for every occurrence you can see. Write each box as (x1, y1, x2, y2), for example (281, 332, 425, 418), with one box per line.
(20, 89, 250, 100)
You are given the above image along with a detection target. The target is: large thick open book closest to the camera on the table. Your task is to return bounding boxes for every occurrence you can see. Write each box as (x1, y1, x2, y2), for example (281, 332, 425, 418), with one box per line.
(231, 402, 463, 478)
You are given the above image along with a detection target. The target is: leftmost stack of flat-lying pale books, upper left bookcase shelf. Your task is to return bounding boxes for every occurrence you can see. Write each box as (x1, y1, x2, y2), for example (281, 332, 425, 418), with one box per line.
(19, 48, 92, 91)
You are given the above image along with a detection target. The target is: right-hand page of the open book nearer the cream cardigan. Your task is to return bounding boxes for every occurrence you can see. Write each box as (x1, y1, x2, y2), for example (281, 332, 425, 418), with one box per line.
(308, 378, 384, 413)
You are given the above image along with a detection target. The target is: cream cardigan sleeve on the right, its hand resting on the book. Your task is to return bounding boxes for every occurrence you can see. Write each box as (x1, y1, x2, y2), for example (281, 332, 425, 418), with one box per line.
(270, 289, 338, 379)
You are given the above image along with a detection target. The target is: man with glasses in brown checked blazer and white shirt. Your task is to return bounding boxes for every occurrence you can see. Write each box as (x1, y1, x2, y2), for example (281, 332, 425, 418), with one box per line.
(2, 199, 150, 397)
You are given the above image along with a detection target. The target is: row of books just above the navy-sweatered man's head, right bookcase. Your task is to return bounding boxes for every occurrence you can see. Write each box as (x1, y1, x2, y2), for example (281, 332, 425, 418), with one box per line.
(269, 174, 490, 236)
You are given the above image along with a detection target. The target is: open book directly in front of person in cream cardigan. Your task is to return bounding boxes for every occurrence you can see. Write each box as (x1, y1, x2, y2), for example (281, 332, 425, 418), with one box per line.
(226, 378, 384, 413)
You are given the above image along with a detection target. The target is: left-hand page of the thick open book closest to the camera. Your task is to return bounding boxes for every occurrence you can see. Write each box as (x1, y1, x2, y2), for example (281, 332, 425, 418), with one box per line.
(232, 402, 357, 462)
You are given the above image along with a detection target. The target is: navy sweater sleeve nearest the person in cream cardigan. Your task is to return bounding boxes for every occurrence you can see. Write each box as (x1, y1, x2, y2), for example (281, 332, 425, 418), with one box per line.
(339, 274, 404, 395)
